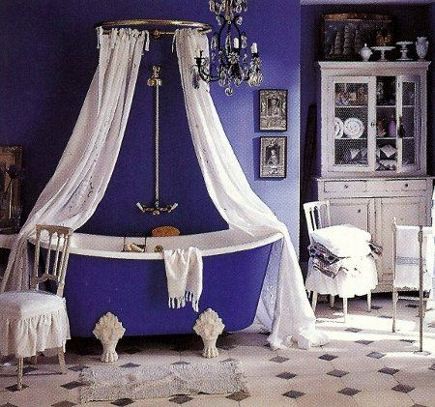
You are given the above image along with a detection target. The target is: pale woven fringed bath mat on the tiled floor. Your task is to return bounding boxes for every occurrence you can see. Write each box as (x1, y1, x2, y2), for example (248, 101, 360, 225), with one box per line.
(80, 361, 246, 403)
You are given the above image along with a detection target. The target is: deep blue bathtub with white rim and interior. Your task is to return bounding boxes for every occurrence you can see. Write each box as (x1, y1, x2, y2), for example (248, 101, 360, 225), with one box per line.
(60, 230, 281, 337)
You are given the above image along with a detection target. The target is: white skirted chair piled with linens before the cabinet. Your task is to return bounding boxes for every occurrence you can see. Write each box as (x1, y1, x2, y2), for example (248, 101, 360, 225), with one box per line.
(304, 201, 378, 322)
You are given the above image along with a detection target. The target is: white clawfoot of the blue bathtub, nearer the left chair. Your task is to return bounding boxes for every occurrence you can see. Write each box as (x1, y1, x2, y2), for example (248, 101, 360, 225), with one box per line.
(93, 312, 125, 363)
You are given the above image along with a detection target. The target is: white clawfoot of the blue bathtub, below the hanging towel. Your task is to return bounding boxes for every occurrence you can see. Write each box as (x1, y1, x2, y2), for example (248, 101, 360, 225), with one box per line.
(193, 308, 225, 359)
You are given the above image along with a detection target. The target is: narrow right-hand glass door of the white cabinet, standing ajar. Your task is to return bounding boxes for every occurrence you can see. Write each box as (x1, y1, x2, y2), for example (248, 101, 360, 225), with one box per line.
(397, 76, 420, 172)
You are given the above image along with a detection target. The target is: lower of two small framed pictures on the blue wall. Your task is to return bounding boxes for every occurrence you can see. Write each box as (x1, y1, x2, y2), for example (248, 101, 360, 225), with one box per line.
(260, 136, 287, 178)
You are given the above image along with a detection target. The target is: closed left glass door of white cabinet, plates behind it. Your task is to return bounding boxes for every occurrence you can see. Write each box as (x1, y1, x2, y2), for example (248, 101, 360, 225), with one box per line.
(328, 77, 375, 172)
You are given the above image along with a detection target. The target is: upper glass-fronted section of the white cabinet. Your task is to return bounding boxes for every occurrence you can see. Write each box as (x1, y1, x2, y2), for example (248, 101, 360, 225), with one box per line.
(319, 62, 429, 177)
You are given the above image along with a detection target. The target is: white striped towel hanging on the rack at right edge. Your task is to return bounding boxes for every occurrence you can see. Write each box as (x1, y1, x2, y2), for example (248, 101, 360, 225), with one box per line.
(394, 225, 434, 291)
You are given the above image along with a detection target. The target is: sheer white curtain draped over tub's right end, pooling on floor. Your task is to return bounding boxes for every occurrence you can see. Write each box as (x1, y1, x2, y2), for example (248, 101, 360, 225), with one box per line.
(175, 29, 327, 349)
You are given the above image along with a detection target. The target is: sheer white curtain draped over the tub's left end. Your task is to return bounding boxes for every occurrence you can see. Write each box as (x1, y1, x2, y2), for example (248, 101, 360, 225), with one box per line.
(1, 29, 148, 292)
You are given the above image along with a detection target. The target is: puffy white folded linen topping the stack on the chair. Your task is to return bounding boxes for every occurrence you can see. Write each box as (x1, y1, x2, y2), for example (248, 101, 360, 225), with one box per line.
(311, 224, 372, 257)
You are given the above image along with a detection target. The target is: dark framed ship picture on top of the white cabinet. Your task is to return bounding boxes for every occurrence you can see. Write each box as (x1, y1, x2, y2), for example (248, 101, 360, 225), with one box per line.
(321, 13, 394, 61)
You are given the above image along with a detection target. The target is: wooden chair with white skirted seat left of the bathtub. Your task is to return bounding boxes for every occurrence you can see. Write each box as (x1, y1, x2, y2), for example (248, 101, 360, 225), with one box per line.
(0, 225, 73, 390)
